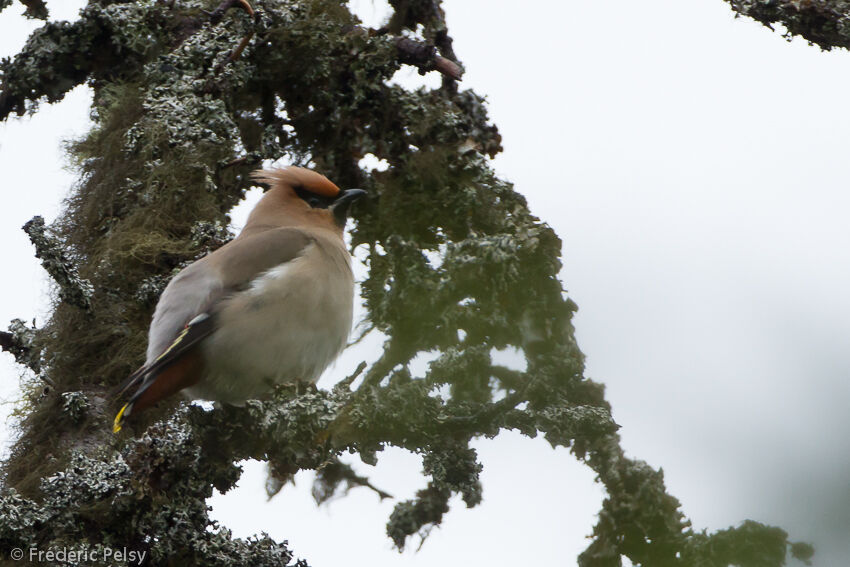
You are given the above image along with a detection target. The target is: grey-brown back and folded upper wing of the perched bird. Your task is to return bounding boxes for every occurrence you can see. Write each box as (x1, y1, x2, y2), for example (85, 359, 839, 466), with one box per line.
(145, 228, 314, 365)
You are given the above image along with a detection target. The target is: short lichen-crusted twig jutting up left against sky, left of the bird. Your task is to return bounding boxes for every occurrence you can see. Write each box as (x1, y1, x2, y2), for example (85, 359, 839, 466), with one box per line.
(23, 216, 94, 309)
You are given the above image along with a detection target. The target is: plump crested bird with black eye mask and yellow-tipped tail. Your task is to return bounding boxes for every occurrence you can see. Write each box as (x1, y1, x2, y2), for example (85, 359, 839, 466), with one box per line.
(113, 167, 365, 433)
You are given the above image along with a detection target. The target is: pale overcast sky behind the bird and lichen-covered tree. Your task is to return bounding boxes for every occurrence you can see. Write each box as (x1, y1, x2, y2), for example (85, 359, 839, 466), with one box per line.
(0, 0, 850, 567)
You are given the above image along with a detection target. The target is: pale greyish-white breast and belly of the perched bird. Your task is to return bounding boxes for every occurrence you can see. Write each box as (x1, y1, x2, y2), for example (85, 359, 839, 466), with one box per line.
(187, 244, 354, 404)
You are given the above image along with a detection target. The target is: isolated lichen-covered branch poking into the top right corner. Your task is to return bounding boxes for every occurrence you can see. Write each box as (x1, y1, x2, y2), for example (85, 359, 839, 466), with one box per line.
(726, 0, 850, 50)
